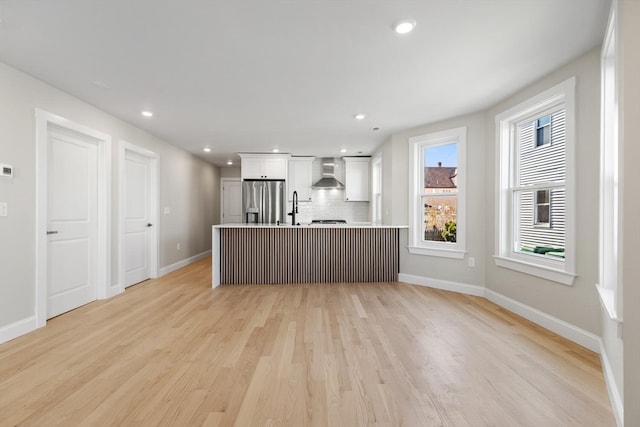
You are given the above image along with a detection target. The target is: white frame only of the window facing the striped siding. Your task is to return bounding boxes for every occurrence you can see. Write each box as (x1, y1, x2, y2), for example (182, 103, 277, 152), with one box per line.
(494, 77, 576, 285)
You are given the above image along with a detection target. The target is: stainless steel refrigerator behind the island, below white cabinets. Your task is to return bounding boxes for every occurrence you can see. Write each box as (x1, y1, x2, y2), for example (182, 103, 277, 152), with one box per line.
(242, 179, 287, 224)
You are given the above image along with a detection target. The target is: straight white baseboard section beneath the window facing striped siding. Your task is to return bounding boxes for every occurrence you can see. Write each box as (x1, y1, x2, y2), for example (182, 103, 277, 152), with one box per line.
(484, 289, 600, 353)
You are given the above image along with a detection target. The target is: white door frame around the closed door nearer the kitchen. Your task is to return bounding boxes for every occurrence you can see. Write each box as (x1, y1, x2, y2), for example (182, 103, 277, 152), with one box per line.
(117, 140, 160, 293)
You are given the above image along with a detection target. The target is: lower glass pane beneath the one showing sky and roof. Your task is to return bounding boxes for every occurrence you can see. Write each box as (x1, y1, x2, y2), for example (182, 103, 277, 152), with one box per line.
(422, 195, 458, 242)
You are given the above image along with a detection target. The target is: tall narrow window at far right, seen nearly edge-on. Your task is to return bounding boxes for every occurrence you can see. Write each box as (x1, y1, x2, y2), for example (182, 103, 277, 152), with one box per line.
(597, 2, 622, 322)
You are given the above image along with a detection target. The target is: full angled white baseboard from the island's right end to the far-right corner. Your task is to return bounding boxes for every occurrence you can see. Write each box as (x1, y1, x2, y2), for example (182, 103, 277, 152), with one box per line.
(398, 273, 600, 353)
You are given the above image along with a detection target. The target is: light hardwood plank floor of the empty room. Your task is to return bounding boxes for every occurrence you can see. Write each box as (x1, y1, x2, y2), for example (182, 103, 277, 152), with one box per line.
(0, 259, 614, 427)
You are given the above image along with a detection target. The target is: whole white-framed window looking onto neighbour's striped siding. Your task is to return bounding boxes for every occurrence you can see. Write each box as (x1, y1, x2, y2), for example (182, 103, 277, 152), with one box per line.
(495, 78, 575, 284)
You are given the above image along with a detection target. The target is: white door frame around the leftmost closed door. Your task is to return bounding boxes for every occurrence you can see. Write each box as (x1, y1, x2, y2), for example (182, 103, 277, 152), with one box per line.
(35, 108, 113, 328)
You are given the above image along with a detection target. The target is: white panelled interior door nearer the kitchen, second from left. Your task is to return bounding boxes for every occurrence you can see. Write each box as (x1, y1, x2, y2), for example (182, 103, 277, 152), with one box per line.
(124, 150, 156, 287)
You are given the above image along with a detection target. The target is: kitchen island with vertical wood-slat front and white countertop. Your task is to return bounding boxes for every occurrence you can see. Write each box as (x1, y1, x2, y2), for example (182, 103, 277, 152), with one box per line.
(212, 223, 407, 288)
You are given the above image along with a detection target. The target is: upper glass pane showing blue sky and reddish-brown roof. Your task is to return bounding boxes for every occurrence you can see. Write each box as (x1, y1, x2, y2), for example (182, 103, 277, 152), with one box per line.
(423, 142, 458, 193)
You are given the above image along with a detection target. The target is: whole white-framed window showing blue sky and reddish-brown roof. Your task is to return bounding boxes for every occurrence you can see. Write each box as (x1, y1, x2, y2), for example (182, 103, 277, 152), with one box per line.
(409, 127, 467, 259)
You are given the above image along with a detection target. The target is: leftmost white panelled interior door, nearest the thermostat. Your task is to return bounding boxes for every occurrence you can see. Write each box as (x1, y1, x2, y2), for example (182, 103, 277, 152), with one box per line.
(47, 127, 98, 319)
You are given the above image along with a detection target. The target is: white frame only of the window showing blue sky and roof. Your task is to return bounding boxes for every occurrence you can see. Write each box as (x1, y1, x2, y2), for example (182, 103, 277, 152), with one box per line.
(407, 126, 467, 259)
